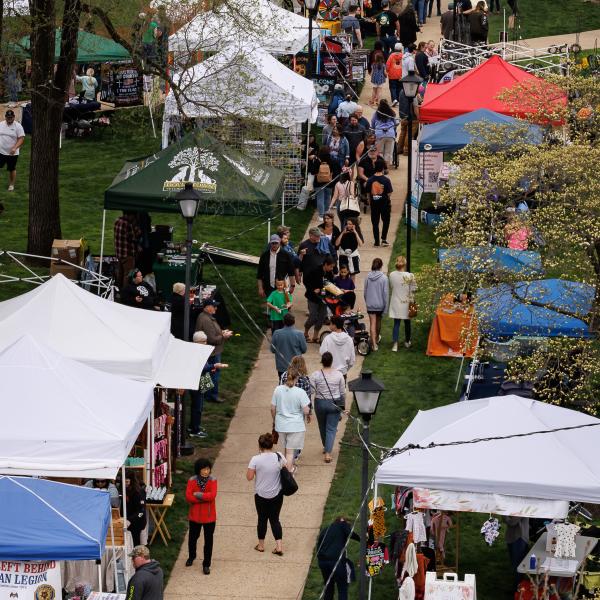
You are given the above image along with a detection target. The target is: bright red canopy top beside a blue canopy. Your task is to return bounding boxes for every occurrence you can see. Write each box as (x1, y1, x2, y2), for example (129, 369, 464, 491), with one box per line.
(419, 56, 566, 123)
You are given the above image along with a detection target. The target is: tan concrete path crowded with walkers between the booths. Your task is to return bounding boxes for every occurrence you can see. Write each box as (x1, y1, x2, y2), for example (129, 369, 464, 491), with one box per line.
(165, 50, 410, 600)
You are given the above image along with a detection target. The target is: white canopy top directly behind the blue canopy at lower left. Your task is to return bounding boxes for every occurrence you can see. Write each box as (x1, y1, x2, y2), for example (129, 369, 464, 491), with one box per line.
(0, 335, 154, 479)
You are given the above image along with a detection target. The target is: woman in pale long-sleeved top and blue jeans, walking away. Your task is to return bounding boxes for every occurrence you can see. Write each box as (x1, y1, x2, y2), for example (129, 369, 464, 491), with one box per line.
(310, 352, 346, 463)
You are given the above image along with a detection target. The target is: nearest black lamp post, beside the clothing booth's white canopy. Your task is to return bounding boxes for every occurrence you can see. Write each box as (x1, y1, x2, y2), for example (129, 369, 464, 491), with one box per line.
(348, 371, 385, 600)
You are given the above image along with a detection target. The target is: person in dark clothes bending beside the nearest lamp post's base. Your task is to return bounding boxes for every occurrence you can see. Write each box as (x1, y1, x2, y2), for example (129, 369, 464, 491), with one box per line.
(317, 517, 360, 600)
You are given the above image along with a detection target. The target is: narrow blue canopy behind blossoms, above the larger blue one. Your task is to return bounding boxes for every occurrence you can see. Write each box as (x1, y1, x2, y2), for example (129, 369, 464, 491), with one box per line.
(438, 246, 543, 277)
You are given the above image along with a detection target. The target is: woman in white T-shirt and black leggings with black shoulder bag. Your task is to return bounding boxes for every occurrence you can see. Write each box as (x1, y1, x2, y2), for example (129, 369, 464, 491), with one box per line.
(246, 433, 286, 556)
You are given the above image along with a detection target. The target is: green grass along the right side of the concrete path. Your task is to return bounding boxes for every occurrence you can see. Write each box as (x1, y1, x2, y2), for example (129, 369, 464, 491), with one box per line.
(304, 227, 511, 600)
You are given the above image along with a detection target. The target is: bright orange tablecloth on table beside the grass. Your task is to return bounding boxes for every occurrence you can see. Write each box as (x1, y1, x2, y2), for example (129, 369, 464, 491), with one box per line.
(427, 294, 478, 357)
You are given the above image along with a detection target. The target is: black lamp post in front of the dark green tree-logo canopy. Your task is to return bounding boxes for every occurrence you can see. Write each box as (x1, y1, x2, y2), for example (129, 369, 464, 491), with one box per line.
(175, 181, 200, 456)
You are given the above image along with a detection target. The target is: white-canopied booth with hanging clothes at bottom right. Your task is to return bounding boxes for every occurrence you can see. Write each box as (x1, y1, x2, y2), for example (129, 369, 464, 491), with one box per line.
(374, 396, 600, 600)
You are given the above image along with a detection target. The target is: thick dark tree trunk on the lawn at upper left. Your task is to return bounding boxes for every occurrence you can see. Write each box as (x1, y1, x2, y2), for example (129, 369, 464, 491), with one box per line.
(27, 0, 81, 256)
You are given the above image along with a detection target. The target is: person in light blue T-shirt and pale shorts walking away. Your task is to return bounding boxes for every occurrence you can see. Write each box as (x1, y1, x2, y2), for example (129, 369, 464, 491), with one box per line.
(271, 371, 310, 473)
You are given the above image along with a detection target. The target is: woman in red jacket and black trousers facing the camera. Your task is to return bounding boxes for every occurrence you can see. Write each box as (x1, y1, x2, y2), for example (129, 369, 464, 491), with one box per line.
(185, 458, 217, 575)
